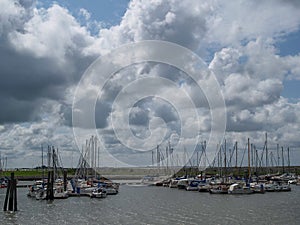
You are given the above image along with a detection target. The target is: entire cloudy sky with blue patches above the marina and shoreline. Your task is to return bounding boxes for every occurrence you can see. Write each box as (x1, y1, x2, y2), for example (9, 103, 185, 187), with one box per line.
(0, 0, 300, 168)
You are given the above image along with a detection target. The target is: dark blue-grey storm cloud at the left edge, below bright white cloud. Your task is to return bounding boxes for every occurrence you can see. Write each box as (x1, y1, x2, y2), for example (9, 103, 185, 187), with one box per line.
(0, 42, 92, 123)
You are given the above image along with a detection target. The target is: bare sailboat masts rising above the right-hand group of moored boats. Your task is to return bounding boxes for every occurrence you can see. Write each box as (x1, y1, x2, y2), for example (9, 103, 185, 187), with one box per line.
(152, 133, 291, 176)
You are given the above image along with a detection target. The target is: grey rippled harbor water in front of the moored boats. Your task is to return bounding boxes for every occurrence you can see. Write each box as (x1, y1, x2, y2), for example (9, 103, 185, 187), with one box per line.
(0, 185, 300, 225)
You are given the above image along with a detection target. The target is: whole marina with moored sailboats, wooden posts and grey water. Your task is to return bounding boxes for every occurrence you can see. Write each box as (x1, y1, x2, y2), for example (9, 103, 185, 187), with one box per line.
(0, 139, 300, 225)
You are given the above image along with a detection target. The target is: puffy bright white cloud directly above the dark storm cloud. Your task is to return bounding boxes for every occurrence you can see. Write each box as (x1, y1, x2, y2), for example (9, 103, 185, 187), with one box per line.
(9, 4, 93, 60)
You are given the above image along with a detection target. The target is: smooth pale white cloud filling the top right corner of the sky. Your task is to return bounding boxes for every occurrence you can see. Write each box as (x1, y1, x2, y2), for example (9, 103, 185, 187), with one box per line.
(208, 0, 300, 46)
